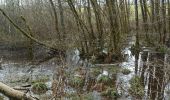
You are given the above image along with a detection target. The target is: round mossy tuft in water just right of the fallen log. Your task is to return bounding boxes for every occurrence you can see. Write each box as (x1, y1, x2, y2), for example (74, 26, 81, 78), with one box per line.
(31, 82, 48, 94)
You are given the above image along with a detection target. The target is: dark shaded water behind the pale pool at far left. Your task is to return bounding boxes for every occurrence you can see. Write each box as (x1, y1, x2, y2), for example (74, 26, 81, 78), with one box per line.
(0, 42, 49, 63)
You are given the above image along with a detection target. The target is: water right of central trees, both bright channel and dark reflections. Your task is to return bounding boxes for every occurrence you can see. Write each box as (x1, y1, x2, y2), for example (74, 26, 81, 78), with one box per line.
(117, 34, 170, 100)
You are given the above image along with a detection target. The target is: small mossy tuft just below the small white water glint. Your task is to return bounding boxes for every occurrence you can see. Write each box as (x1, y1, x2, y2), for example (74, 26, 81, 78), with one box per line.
(97, 75, 112, 85)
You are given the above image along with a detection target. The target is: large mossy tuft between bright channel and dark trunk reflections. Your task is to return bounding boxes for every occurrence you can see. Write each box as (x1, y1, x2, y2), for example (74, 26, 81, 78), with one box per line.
(129, 76, 144, 98)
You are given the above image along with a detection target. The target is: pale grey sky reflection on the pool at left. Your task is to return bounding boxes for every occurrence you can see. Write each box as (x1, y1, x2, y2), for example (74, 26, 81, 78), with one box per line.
(0, 63, 53, 85)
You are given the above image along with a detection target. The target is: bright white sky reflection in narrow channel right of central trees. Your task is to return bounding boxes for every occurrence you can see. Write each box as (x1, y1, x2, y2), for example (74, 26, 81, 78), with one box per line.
(117, 37, 135, 100)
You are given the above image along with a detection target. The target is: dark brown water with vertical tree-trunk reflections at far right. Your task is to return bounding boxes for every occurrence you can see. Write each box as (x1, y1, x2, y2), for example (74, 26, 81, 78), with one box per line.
(141, 52, 167, 100)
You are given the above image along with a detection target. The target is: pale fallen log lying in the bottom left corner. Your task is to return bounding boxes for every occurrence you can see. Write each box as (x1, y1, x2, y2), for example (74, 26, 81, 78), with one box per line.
(0, 82, 37, 100)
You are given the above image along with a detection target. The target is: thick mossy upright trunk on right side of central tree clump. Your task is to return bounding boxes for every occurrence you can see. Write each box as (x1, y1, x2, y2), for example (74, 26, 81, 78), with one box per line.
(106, 0, 121, 56)
